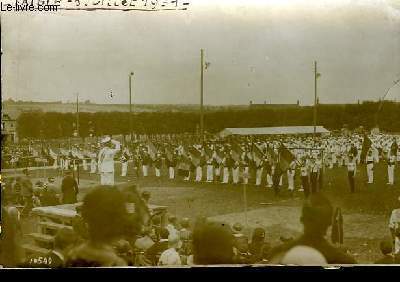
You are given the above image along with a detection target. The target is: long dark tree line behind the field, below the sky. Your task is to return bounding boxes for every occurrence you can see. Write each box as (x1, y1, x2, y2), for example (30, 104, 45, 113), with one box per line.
(17, 102, 400, 139)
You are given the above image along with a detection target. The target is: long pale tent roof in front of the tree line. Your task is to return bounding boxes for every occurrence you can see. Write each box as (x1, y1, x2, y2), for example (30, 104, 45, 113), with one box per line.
(220, 126, 329, 136)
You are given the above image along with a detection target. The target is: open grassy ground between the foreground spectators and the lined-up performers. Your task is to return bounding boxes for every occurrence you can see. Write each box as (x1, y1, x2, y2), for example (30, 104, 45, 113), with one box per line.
(4, 161, 400, 263)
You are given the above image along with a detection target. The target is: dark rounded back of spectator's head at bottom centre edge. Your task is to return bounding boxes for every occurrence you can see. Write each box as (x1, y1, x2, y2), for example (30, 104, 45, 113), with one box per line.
(193, 219, 234, 265)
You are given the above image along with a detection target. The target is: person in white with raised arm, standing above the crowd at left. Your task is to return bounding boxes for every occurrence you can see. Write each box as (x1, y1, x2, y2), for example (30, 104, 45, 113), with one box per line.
(98, 137, 121, 185)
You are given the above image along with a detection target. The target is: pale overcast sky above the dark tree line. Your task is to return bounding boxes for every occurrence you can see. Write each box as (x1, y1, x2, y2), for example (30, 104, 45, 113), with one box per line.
(1, 0, 400, 105)
